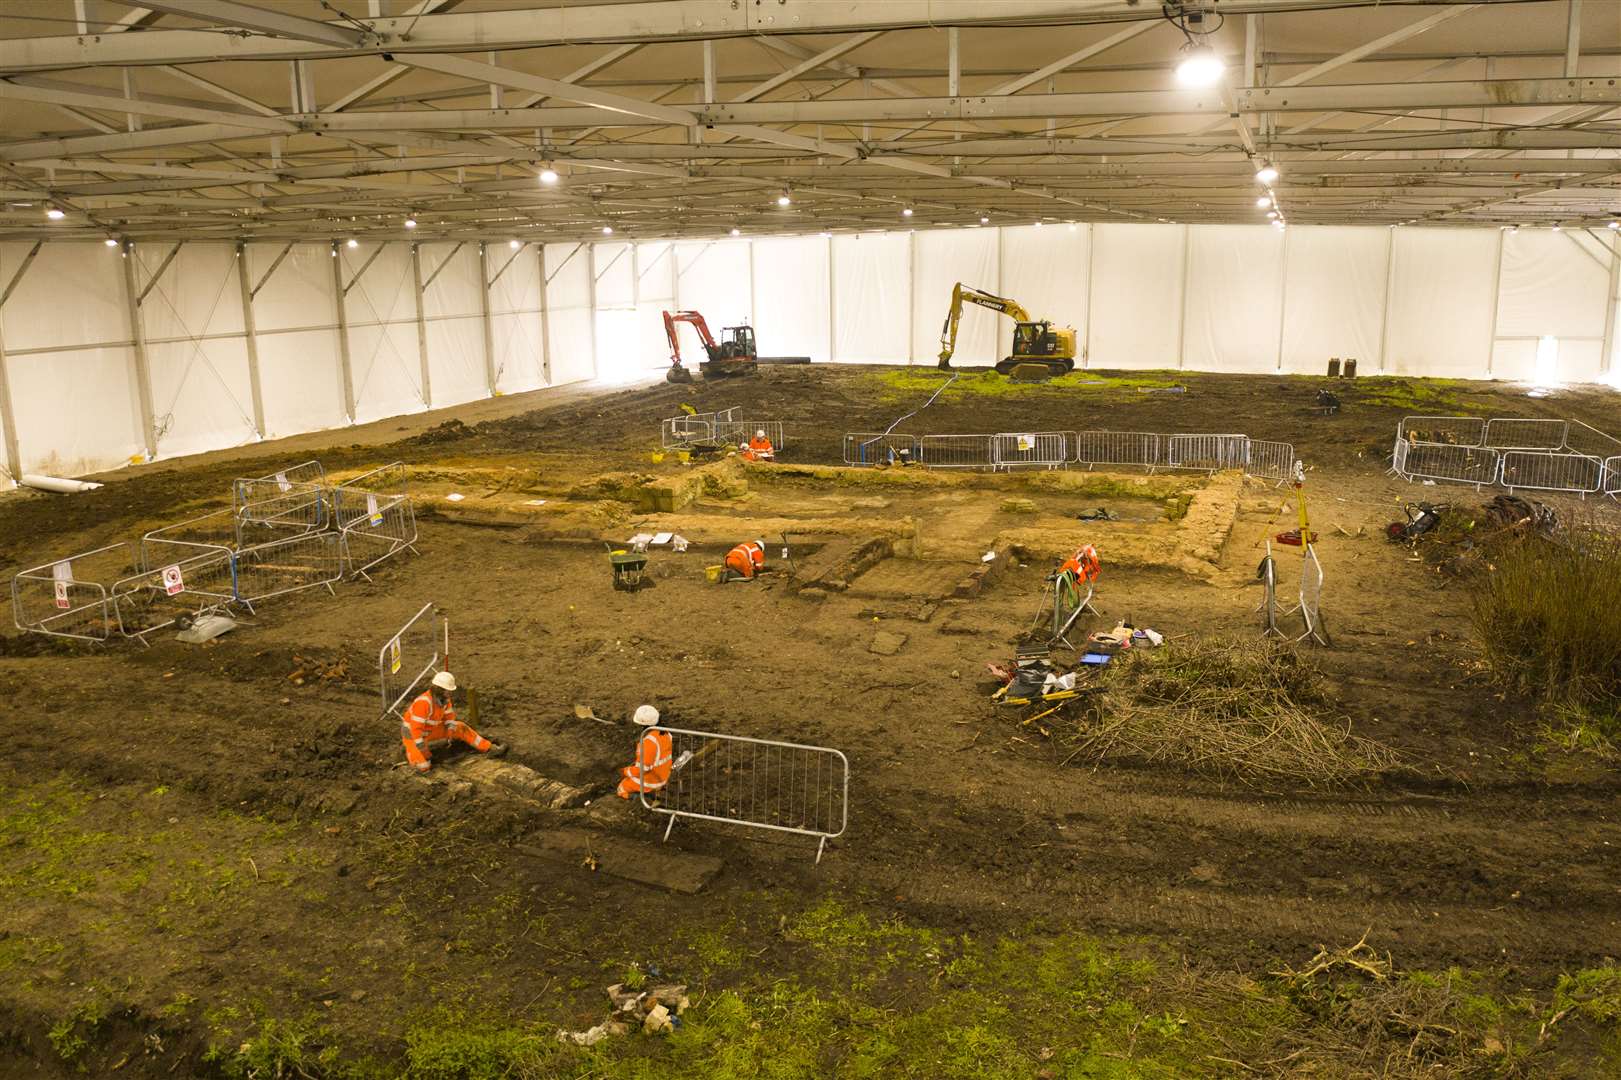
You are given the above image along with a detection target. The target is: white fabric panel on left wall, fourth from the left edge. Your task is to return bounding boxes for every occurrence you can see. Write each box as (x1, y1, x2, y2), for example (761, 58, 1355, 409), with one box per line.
(337, 243, 423, 423)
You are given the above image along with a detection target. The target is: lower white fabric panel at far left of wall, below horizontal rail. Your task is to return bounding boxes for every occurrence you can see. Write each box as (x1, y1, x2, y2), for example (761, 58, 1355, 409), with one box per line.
(5, 348, 146, 477)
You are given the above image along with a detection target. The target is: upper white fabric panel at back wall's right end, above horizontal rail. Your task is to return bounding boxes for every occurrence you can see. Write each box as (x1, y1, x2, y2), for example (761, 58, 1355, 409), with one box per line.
(1493, 229, 1610, 338)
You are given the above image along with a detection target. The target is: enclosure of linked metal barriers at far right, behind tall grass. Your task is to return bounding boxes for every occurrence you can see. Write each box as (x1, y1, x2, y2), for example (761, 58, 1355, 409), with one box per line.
(1391, 417, 1621, 496)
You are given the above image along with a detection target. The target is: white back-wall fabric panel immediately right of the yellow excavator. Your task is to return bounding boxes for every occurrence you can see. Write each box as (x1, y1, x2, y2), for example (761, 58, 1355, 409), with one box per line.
(1088, 225, 1185, 368)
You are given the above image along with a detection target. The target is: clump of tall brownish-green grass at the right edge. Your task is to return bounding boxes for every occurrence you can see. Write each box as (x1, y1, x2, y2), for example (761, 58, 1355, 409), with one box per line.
(1472, 527, 1621, 754)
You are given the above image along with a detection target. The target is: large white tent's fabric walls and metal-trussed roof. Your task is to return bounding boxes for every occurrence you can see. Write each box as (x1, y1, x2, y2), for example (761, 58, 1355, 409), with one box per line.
(0, 0, 1621, 485)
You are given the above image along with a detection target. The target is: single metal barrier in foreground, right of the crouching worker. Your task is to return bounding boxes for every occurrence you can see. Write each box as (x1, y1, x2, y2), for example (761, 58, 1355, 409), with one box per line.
(635, 726, 849, 863)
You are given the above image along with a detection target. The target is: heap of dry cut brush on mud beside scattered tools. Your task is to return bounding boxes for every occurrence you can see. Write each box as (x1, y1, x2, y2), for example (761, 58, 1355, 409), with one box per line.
(1055, 639, 1399, 788)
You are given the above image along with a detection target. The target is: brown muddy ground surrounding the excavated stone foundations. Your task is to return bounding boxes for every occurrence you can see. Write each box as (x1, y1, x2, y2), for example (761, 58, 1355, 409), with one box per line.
(0, 366, 1621, 1075)
